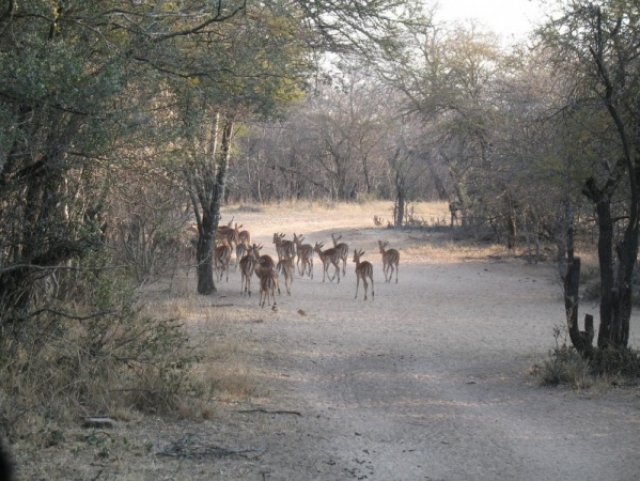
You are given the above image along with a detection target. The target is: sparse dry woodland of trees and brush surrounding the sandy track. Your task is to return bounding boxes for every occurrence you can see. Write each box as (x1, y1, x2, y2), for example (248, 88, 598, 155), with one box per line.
(0, 0, 640, 462)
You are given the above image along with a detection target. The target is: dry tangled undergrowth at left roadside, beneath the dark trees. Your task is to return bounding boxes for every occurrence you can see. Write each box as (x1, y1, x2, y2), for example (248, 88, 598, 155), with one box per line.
(0, 251, 199, 444)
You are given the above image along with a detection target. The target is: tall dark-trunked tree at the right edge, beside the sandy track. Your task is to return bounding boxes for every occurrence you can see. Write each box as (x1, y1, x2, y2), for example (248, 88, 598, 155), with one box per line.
(541, 0, 640, 355)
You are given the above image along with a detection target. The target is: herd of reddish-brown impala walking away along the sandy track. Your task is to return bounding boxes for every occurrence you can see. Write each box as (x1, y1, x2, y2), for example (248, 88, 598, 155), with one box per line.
(214, 219, 400, 307)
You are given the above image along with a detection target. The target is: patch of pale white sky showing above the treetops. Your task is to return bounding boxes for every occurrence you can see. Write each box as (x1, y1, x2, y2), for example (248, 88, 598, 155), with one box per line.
(438, 0, 545, 42)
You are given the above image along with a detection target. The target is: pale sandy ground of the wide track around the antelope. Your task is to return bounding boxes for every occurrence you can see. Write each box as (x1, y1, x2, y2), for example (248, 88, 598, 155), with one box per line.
(17, 202, 640, 481)
